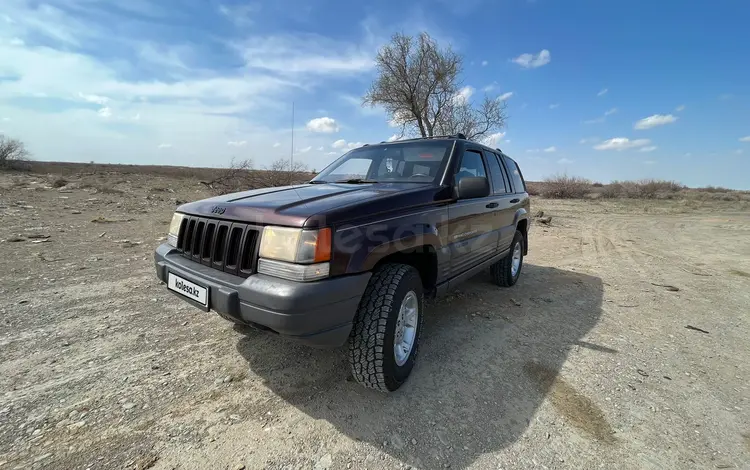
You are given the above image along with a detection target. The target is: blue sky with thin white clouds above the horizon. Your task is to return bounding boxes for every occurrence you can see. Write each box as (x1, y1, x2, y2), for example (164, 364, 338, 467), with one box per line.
(0, 0, 750, 189)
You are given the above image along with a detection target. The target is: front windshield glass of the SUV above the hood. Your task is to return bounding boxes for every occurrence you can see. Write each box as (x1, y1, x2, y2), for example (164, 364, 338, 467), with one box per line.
(313, 140, 453, 183)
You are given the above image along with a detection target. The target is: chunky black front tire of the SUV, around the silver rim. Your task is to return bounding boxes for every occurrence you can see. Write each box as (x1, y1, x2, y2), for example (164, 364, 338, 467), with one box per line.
(349, 264, 424, 392)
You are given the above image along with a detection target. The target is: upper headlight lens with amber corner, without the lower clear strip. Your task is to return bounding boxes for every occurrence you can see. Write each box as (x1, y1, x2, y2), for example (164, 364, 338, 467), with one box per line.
(260, 226, 331, 264)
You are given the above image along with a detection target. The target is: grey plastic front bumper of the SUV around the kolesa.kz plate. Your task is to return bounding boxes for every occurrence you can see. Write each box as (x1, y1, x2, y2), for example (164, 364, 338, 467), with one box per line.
(154, 243, 370, 347)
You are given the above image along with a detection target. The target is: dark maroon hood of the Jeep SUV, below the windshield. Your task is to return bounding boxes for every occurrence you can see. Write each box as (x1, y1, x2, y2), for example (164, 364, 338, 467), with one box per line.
(177, 183, 441, 228)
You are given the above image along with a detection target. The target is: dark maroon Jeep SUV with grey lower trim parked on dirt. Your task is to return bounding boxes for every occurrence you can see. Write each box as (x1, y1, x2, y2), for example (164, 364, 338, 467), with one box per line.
(155, 135, 529, 391)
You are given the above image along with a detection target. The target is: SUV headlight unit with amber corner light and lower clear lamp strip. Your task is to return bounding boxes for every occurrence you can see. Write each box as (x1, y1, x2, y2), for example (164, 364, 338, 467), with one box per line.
(258, 226, 331, 281)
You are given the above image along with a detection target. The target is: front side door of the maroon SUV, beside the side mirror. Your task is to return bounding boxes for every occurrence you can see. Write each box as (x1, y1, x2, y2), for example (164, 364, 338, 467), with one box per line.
(448, 145, 498, 276)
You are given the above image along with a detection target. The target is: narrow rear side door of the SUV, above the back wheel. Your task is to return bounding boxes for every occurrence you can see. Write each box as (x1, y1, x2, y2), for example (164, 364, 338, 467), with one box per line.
(484, 151, 517, 251)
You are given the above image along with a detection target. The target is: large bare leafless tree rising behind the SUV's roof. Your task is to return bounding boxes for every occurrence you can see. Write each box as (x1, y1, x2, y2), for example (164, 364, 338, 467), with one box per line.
(363, 33, 506, 140)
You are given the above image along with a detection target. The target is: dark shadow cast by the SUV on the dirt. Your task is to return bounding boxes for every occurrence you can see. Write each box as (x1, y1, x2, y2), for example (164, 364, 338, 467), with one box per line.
(237, 264, 617, 468)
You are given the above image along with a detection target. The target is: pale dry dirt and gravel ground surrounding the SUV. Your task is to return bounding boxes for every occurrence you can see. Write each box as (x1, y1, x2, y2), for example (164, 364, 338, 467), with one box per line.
(0, 174, 750, 470)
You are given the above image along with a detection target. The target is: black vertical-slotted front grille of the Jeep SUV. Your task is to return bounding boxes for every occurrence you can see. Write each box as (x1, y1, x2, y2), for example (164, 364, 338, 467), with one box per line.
(177, 216, 260, 277)
